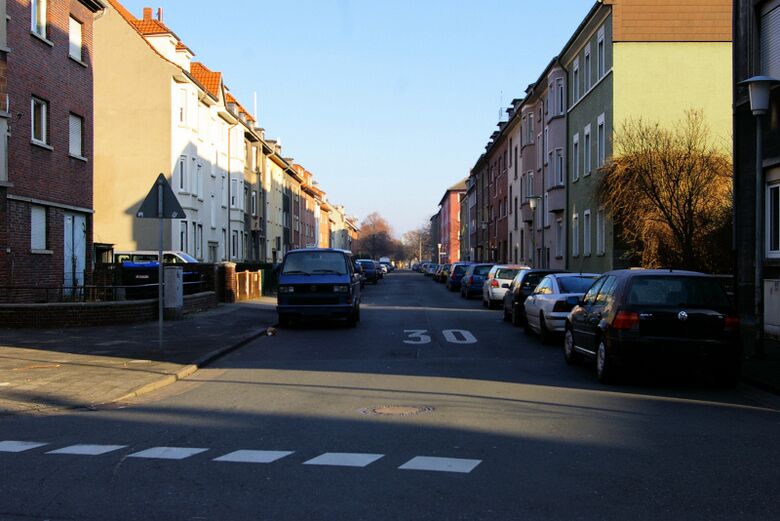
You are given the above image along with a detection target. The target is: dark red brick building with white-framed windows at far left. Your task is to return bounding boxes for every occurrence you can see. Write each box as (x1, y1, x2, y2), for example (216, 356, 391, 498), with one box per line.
(0, 0, 105, 299)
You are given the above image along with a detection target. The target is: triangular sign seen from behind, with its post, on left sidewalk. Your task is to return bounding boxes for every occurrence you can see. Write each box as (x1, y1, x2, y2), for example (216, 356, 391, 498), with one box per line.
(135, 174, 187, 351)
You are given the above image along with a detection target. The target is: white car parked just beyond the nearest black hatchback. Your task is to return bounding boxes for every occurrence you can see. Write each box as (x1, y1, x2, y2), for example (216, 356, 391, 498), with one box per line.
(524, 273, 599, 344)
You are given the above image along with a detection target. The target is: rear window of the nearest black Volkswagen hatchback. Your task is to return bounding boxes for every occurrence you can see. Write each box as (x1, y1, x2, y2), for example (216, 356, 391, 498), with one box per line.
(627, 275, 730, 308)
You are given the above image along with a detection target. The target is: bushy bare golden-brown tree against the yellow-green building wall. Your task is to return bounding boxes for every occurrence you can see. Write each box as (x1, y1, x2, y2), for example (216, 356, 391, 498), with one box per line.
(598, 111, 732, 271)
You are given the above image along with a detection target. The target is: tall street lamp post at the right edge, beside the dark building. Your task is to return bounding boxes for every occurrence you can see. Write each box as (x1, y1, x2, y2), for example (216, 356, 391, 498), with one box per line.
(738, 76, 780, 358)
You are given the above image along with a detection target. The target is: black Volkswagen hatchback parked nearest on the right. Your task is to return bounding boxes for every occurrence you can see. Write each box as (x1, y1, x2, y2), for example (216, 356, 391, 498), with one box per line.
(564, 269, 741, 385)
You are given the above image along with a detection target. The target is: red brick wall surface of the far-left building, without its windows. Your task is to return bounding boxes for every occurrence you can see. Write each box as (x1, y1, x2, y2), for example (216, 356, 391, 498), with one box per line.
(0, 0, 95, 286)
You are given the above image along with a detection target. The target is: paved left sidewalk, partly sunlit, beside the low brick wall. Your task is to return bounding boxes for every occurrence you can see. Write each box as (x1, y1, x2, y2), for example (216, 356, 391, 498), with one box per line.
(0, 297, 276, 416)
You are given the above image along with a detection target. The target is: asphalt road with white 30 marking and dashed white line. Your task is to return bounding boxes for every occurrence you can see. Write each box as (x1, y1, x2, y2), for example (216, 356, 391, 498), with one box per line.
(0, 273, 780, 521)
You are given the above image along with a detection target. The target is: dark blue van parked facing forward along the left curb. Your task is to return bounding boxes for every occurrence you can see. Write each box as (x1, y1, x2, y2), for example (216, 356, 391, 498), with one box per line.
(276, 248, 360, 327)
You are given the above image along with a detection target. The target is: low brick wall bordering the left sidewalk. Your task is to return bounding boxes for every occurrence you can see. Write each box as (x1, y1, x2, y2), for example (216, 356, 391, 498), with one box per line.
(0, 291, 217, 329)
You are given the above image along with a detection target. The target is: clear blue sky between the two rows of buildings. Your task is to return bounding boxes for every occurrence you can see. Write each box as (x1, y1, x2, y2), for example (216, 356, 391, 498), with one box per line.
(123, 0, 594, 236)
